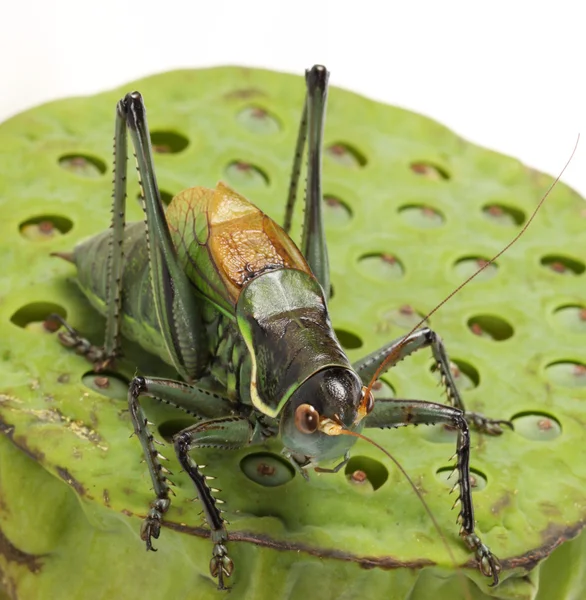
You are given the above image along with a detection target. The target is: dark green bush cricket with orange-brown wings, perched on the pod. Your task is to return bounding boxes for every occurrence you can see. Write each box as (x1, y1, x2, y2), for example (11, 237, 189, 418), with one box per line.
(56, 65, 512, 589)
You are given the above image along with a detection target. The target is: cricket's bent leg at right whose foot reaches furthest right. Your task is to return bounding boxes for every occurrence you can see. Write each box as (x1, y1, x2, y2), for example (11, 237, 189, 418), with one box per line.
(353, 327, 513, 435)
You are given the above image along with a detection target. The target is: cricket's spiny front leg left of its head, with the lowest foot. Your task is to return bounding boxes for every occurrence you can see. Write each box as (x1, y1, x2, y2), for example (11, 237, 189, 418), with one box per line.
(173, 417, 254, 590)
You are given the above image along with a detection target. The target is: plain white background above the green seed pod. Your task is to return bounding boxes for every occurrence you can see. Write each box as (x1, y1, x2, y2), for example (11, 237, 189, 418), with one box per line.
(0, 0, 586, 195)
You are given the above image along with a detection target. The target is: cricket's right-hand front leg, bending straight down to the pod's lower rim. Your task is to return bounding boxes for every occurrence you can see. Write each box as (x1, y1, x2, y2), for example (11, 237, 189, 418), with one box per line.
(366, 399, 501, 585)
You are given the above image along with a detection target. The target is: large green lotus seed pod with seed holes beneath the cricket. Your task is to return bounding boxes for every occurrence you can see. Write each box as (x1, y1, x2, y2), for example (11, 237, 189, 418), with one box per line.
(0, 67, 586, 600)
